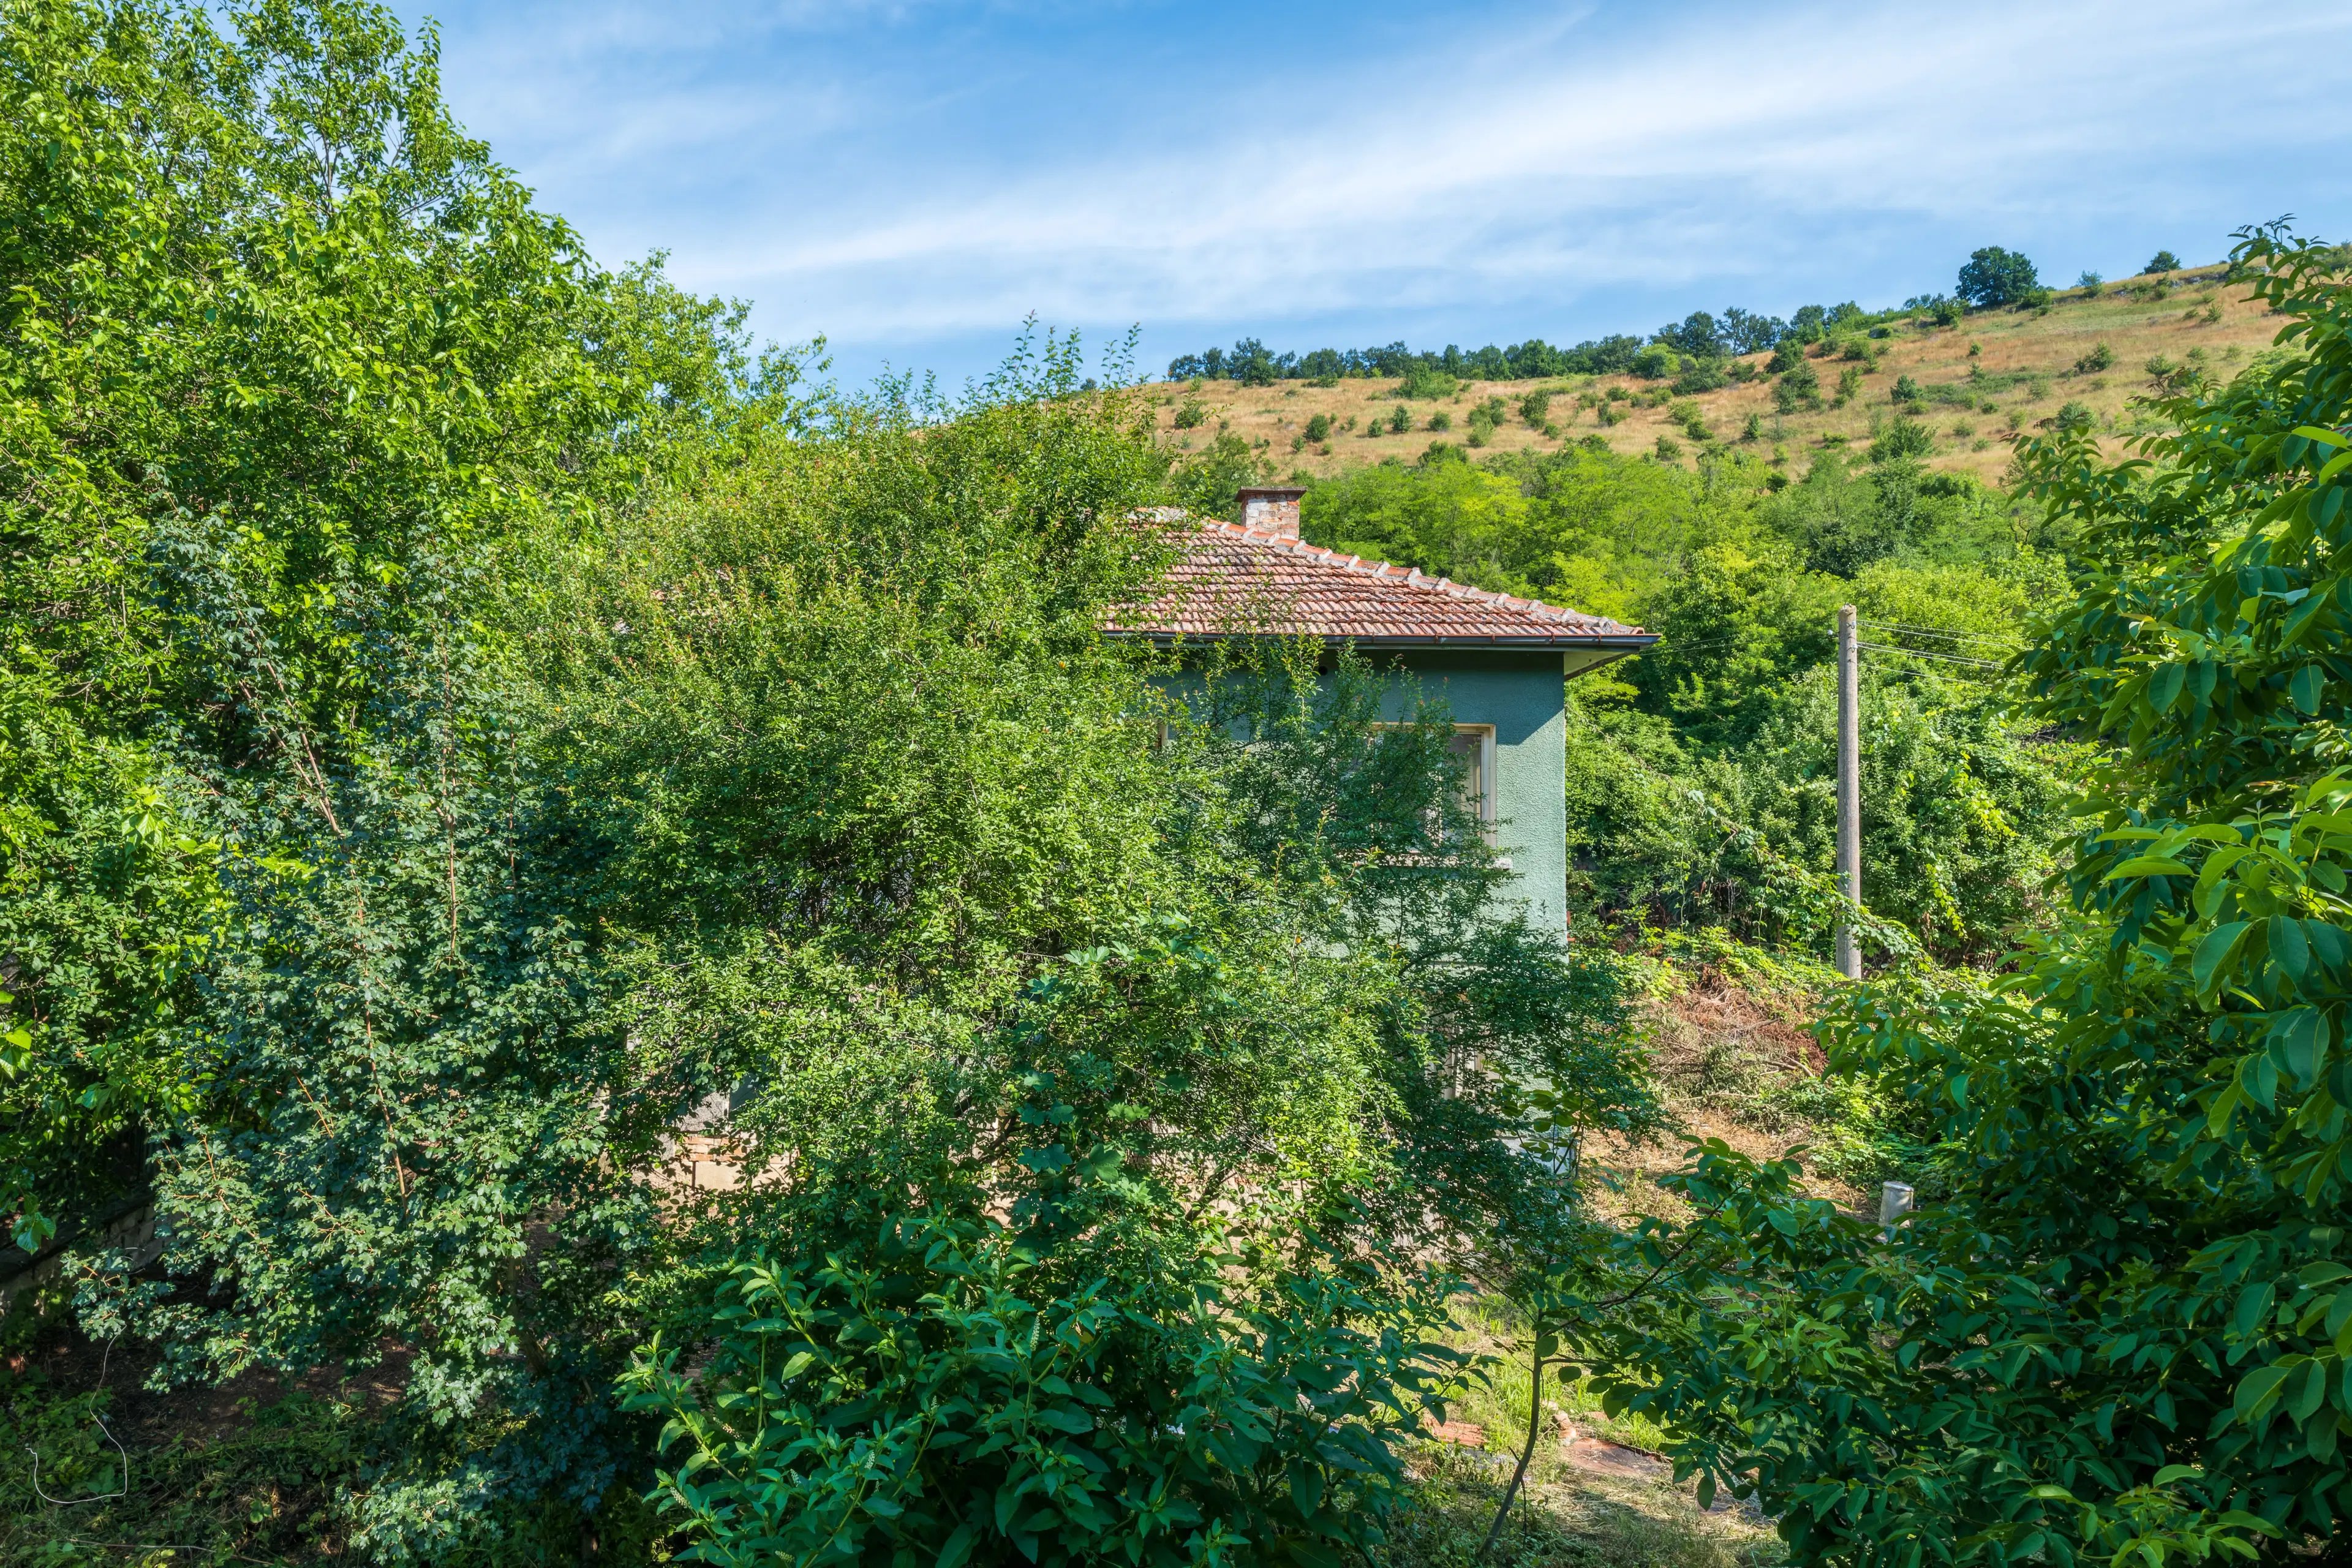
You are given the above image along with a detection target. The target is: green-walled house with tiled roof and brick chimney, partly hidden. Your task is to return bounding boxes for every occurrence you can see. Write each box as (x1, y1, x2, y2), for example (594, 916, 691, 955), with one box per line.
(1106, 486, 1658, 931)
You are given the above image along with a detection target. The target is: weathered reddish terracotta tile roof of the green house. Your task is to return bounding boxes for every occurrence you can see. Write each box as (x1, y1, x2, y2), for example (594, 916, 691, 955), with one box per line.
(1103, 513, 1656, 651)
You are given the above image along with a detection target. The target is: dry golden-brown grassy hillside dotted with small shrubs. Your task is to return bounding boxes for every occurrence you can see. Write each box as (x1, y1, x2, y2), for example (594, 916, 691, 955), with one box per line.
(1159, 266, 2277, 491)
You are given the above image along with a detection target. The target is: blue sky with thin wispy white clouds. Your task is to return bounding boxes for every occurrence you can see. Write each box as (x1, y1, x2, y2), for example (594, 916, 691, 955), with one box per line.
(400, 0, 2352, 383)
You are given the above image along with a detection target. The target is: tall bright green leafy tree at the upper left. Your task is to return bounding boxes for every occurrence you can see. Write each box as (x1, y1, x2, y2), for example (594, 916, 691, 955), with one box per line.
(0, 2, 800, 1239)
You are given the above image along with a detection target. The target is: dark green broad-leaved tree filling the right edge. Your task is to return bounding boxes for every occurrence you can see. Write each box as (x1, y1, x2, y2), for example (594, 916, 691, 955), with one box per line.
(1580, 230, 2352, 1563)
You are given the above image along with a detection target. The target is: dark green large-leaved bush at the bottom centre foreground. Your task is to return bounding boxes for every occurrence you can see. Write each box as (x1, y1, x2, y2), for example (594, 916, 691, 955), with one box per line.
(628, 1215, 1458, 1566)
